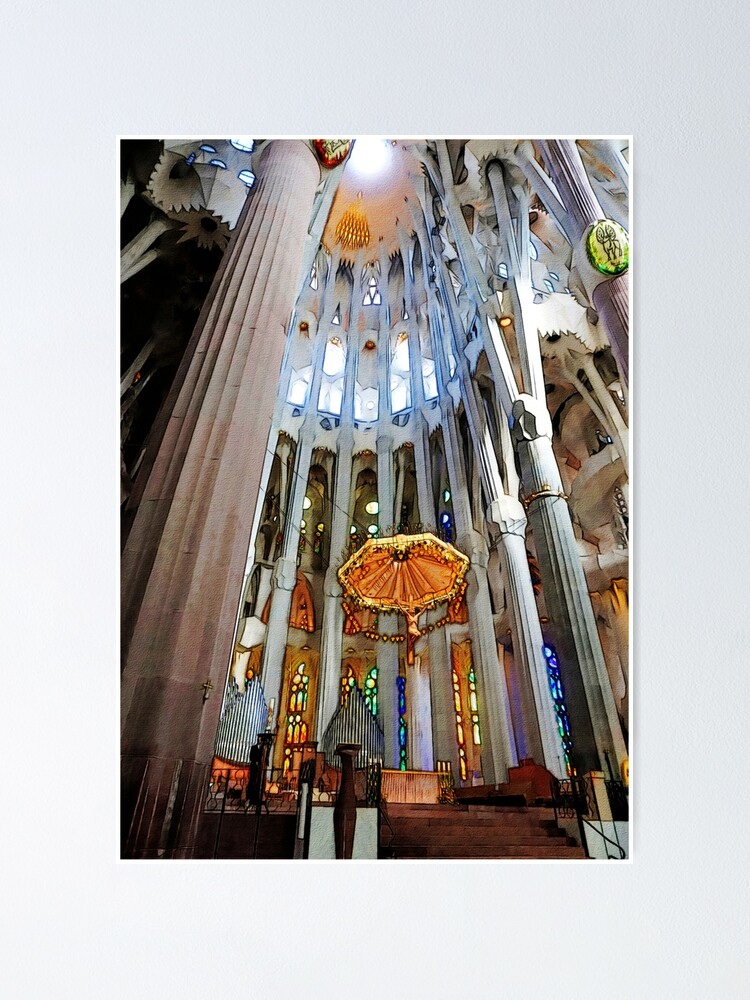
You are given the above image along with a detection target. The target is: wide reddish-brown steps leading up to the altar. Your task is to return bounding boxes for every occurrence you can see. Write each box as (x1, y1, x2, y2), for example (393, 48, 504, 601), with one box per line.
(380, 802, 586, 860)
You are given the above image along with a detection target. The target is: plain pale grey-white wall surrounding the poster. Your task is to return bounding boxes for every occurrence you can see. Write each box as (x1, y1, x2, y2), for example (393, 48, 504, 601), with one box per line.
(0, 0, 750, 1000)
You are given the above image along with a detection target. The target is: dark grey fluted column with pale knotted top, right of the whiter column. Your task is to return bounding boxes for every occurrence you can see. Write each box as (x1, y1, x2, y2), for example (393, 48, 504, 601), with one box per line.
(512, 396, 627, 773)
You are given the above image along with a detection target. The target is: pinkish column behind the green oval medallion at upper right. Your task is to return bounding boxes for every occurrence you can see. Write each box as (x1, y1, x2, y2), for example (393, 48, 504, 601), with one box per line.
(539, 139, 629, 383)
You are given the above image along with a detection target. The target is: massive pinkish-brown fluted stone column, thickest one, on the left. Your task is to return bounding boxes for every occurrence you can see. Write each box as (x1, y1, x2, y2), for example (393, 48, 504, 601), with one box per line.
(121, 140, 320, 856)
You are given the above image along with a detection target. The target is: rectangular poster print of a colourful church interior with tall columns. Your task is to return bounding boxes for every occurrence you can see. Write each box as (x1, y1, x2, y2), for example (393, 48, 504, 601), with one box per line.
(120, 137, 631, 861)
